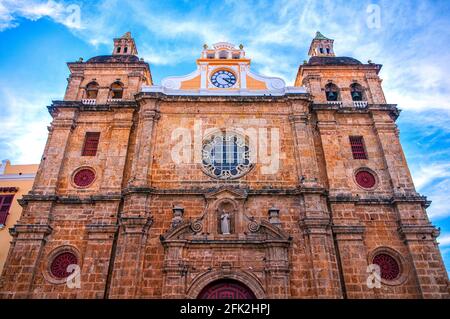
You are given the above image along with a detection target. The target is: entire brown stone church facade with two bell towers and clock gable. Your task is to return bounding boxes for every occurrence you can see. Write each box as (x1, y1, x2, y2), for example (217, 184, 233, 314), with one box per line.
(0, 32, 449, 299)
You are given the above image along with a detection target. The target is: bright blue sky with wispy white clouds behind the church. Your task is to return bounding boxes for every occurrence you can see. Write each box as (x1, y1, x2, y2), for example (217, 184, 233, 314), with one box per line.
(0, 0, 450, 269)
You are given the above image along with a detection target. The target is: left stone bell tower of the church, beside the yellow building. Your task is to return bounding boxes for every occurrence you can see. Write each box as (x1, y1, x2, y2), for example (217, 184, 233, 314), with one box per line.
(0, 32, 152, 298)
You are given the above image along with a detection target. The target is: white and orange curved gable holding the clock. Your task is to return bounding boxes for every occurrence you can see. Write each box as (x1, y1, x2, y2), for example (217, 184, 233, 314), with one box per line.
(142, 42, 306, 95)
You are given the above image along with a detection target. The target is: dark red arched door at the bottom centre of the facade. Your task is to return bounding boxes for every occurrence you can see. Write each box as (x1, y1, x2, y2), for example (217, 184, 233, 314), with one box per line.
(197, 279, 256, 299)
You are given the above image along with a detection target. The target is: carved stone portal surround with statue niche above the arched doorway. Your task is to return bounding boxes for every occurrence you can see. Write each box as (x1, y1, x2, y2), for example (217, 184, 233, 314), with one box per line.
(160, 189, 291, 298)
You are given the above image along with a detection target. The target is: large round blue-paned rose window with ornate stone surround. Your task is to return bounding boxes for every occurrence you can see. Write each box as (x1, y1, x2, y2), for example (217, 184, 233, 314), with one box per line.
(202, 132, 252, 179)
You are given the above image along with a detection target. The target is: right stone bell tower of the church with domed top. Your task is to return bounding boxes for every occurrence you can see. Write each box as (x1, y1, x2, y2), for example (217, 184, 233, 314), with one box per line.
(295, 32, 449, 298)
